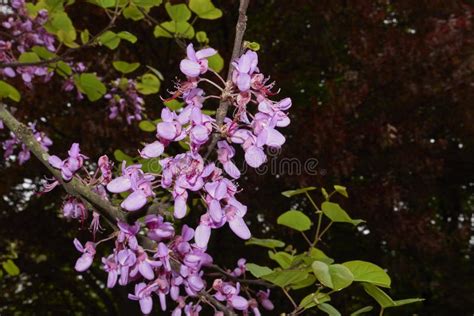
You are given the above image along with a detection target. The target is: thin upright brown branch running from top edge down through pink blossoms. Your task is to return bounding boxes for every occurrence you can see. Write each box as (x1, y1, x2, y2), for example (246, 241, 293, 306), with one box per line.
(205, 0, 249, 158)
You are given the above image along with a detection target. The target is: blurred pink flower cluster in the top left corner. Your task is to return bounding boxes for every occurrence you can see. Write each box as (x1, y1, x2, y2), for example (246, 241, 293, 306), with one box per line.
(0, 0, 56, 87)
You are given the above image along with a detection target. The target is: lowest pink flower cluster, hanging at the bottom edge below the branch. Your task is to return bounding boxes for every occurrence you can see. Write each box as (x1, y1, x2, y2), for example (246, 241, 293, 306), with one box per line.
(74, 215, 273, 315)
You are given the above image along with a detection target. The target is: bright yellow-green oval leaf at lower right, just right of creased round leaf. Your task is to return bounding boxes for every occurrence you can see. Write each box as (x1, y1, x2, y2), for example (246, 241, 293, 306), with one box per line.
(342, 260, 391, 287)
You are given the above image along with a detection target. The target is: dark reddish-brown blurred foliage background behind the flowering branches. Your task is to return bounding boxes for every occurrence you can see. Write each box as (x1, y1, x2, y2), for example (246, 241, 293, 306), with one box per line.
(0, 0, 474, 315)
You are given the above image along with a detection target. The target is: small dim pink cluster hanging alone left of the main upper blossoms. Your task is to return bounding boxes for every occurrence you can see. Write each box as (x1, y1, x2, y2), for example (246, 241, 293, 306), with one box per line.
(105, 78, 145, 125)
